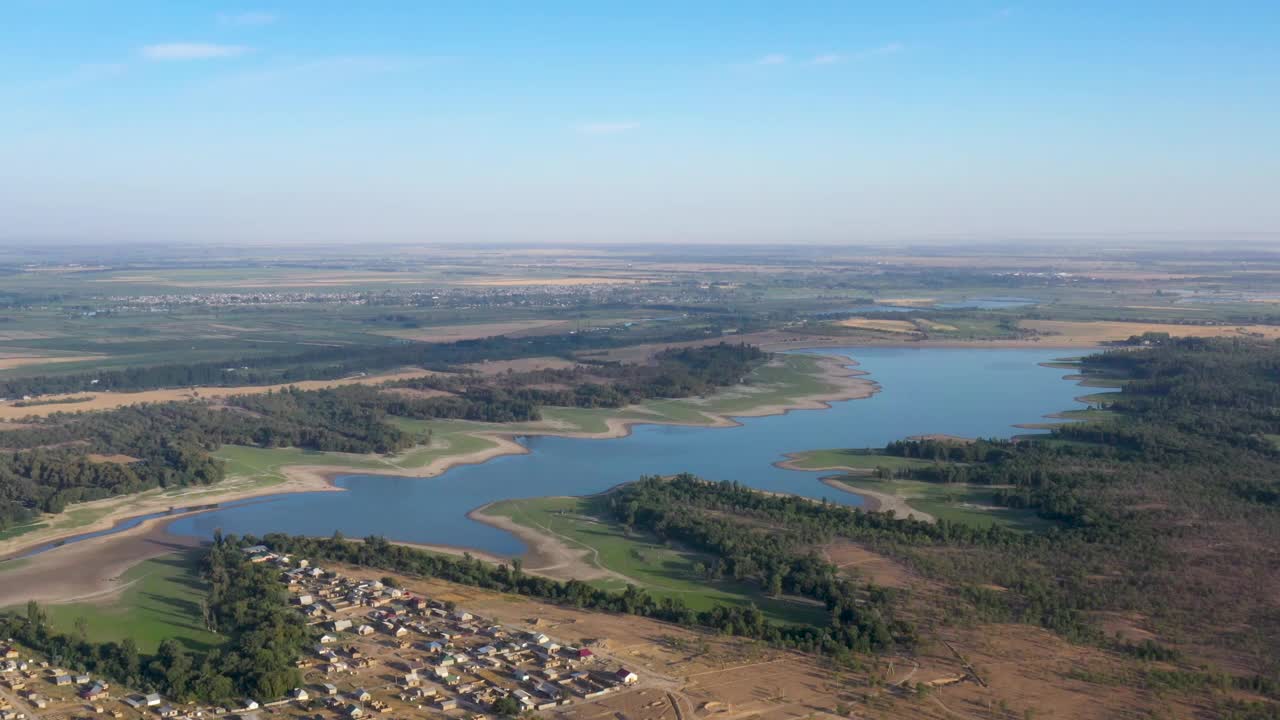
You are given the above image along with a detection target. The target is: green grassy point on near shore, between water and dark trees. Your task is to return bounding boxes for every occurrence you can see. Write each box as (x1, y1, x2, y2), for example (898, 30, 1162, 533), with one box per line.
(486, 497, 826, 624)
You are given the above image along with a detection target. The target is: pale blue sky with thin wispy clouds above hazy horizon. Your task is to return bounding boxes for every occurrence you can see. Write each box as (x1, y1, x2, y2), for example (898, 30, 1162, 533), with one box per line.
(0, 0, 1280, 242)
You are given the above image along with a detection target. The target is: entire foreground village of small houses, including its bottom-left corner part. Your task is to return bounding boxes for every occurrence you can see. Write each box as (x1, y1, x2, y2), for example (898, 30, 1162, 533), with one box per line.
(0, 546, 640, 720)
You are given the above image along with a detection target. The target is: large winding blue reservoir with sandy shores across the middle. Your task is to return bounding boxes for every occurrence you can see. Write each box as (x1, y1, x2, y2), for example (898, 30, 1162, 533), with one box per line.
(170, 347, 1080, 555)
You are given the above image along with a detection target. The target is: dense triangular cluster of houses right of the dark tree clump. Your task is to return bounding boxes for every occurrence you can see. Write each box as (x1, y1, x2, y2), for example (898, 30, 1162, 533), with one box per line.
(267, 546, 640, 719)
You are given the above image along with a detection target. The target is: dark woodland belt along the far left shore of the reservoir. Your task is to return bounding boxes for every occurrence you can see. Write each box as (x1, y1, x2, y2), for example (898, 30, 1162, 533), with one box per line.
(0, 343, 767, 529)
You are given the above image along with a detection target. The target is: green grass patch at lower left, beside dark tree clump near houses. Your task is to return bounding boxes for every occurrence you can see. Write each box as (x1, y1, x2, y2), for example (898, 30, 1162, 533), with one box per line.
(36, 550, 221, 652)
